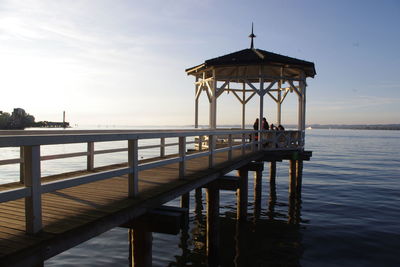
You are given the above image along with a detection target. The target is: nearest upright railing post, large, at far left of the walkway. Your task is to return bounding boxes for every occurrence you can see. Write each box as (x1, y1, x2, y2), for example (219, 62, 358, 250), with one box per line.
(23, 146, 42, 234)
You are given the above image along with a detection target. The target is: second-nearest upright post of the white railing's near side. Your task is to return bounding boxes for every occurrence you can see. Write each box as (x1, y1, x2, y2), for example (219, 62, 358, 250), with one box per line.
(128, 139, 139, 198)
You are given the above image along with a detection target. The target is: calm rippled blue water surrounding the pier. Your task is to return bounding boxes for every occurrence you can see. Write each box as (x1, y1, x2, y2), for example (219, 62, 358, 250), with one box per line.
(0, 130, 400, 266)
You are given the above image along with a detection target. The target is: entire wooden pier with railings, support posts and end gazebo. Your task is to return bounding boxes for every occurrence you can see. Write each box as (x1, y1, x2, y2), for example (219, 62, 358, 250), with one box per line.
(0, 30, 316, 266)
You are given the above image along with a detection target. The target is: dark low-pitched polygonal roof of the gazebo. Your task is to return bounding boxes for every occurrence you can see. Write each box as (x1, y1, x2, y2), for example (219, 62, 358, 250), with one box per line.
(186, 48, 316, 78)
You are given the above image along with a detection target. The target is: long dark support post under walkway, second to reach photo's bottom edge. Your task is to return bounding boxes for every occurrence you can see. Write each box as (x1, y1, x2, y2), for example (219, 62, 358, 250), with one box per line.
(206, 183, 220, 266)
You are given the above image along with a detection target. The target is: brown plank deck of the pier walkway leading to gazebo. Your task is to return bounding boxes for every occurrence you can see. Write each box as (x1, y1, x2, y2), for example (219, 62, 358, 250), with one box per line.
(0, 129, 310, 266)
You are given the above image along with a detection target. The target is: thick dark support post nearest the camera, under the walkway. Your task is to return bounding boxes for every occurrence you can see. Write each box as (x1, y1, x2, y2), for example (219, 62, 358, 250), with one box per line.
(129, 229, 153, 267)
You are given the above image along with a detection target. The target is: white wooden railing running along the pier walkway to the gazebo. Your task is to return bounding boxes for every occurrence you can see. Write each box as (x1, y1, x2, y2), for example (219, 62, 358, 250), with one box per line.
(0, 129, 304, 233)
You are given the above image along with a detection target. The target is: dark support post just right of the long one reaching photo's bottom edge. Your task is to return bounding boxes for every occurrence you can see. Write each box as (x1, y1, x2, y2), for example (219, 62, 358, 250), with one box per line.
(236, 167, 249, 220)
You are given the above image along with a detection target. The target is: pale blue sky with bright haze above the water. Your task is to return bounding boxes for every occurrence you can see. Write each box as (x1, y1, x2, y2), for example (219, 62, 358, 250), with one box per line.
(0, 0, 400, 126)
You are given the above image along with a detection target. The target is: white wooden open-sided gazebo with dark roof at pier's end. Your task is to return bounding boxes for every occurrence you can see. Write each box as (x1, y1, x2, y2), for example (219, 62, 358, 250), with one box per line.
(186, 28, 316, 147)
